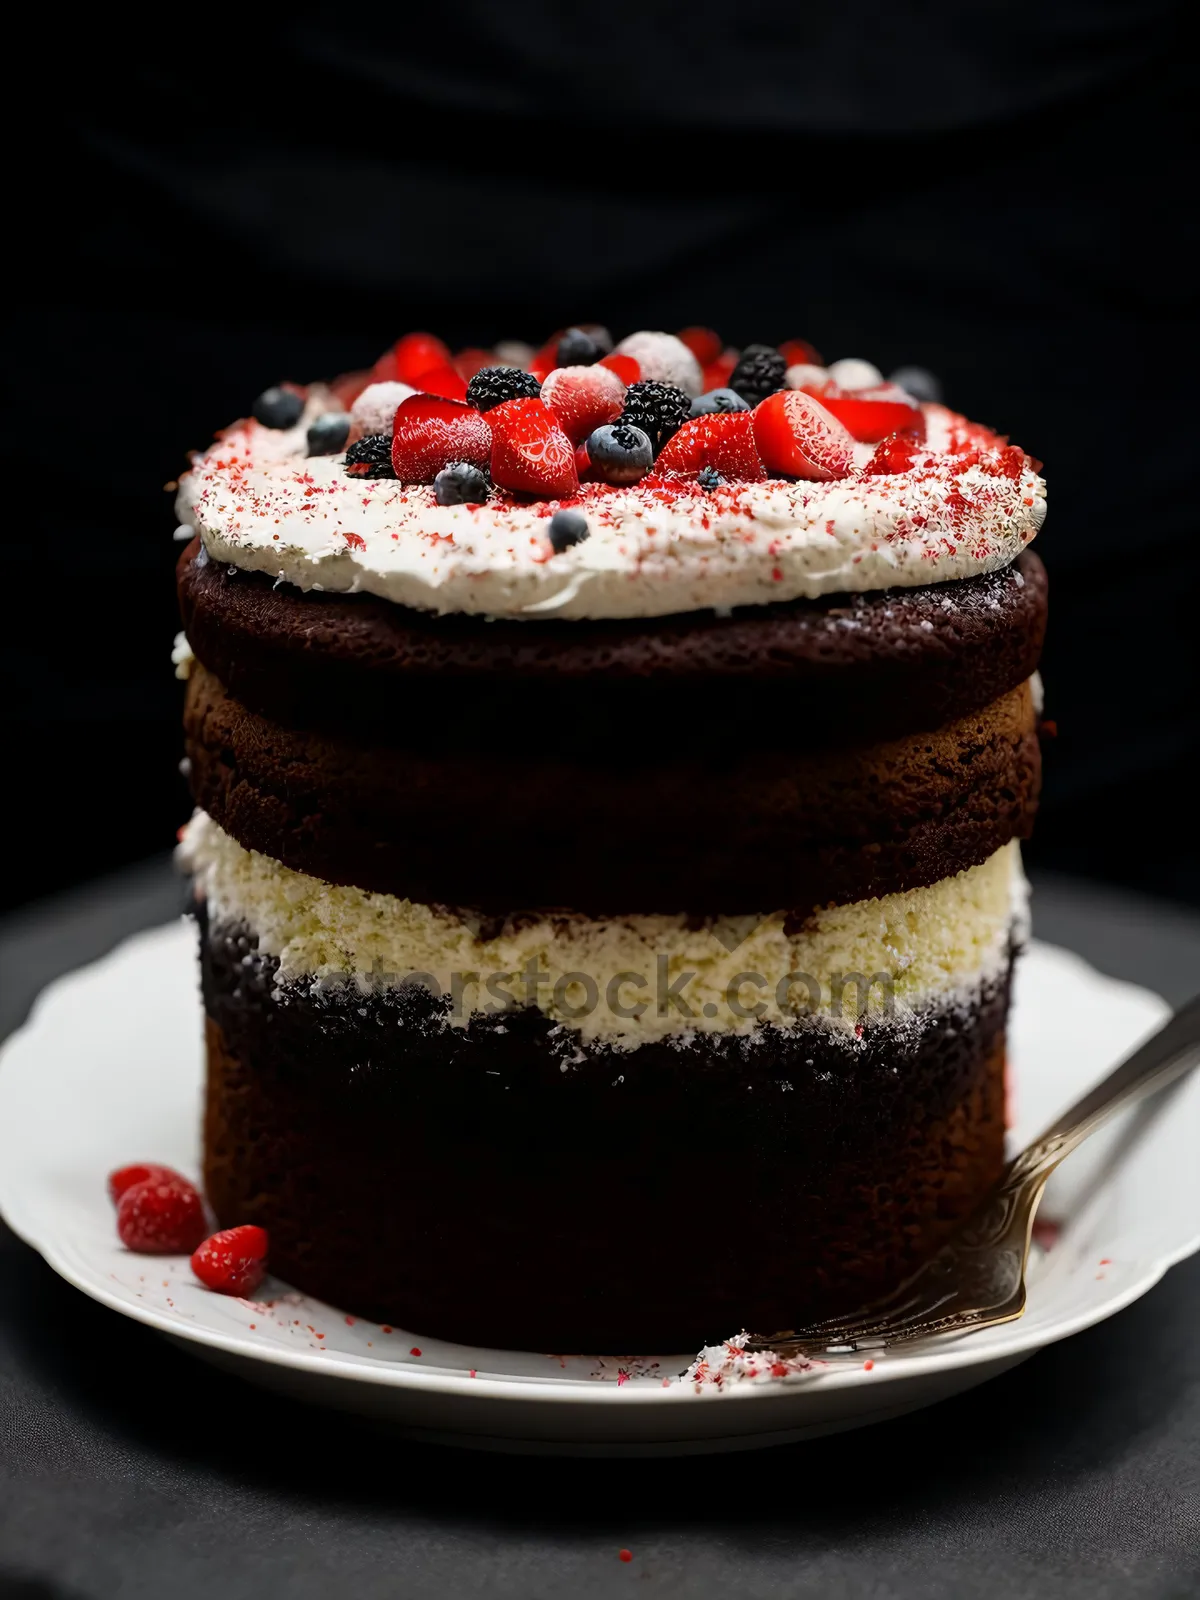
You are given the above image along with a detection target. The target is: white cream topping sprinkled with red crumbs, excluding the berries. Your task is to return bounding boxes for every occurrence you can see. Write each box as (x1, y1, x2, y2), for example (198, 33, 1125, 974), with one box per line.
(178, 389, 1046, 621)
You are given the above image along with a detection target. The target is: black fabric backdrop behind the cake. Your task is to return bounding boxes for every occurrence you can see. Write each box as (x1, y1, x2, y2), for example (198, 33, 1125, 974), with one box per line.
(0, 0, 1200, 904)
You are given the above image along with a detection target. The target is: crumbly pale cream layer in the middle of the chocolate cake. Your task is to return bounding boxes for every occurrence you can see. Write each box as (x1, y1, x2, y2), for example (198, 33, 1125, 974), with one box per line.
(181, 811, 1026, 1048)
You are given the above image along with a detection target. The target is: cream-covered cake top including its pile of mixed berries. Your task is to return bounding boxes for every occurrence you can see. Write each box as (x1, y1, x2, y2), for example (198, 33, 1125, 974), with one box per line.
(178, 328, 1045, 622)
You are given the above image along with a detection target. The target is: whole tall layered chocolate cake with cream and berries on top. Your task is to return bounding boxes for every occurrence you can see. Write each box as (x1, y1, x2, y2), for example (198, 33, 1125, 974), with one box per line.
(178, 326, 1046, 1352)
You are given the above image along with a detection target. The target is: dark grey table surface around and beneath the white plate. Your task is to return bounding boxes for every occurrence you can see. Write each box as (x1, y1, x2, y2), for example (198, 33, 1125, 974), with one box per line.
(0, 861, 1200, 1600)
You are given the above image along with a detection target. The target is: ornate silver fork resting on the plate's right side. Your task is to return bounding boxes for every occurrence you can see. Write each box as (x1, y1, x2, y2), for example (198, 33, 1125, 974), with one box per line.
(746, 995, 1200, 1360)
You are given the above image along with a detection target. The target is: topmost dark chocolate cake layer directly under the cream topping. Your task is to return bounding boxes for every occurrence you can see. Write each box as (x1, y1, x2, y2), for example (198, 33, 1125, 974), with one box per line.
(178, 541, 1046, 748)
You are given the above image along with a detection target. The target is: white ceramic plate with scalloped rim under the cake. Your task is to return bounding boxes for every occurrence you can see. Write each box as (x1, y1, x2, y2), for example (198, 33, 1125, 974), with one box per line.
(0, 923, 1200, 1454)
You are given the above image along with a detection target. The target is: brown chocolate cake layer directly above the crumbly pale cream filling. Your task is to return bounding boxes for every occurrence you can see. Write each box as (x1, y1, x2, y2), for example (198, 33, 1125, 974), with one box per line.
(184, 666, 1040, 915)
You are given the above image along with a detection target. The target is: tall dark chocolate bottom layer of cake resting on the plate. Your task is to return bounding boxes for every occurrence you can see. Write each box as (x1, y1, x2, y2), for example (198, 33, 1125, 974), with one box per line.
(202, 930, 1008, 1352)
